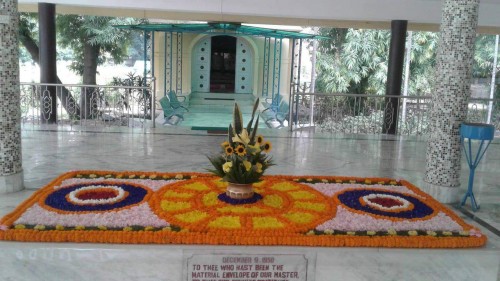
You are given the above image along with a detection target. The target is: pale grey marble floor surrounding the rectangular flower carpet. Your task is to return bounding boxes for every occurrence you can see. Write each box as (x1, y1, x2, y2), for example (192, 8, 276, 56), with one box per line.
(0, 127, 500, 281)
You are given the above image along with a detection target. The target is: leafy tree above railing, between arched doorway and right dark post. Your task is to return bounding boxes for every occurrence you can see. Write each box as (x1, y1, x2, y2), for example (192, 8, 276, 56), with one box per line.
(316, 28, 390, 94)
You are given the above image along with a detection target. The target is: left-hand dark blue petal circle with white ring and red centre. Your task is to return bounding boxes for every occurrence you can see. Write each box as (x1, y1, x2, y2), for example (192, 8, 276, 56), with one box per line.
(39, 182, 150, 212)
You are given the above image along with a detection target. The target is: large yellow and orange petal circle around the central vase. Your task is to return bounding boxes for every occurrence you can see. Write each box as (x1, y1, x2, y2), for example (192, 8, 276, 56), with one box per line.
(150, 177, 335, 232)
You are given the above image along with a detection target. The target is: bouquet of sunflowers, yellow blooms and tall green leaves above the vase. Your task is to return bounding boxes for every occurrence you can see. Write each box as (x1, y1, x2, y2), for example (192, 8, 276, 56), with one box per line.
(208, 99, 273, 184)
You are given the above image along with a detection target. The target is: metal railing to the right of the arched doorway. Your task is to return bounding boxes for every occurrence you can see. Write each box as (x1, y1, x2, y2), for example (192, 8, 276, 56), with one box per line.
(290, 93, 500, 135)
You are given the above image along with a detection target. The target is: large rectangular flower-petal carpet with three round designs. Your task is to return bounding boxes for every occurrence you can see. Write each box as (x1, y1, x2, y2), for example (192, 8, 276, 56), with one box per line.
(0, 168, 487, 248)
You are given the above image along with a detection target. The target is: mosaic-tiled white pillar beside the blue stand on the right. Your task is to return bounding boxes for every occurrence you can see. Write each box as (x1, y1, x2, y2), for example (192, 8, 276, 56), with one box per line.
(425, 0, 479, 203)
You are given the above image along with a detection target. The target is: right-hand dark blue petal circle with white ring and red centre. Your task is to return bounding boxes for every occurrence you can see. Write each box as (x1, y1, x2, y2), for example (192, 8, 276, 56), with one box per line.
(335, 189, 437, 219)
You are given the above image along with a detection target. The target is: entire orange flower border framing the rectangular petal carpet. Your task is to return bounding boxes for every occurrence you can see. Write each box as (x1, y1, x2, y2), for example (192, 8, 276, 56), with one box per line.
(0, 170, 487, 248)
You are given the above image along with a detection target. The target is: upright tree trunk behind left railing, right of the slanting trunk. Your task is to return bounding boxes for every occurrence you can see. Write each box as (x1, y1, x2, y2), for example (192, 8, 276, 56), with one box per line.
(80, 43, 100, 119)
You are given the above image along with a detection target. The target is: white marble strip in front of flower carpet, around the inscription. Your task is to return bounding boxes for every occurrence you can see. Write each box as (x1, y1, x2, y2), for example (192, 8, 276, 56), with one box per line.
(0, 242, 500, 281)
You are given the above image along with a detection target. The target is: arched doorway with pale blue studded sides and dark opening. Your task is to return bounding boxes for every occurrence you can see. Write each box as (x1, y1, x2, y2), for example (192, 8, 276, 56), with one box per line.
(191, 35, 253, 93)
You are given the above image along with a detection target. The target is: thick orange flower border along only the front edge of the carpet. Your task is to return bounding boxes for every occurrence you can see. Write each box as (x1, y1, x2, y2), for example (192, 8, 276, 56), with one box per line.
(0, 229, 486, 248)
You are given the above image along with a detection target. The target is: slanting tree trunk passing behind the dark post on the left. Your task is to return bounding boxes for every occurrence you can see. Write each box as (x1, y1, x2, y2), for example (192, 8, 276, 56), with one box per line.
(19, 31, 80, 118)
